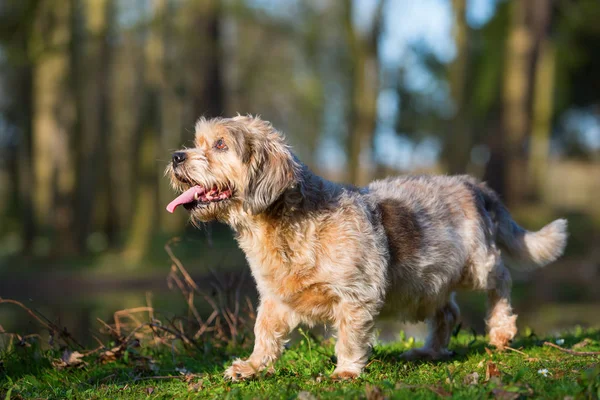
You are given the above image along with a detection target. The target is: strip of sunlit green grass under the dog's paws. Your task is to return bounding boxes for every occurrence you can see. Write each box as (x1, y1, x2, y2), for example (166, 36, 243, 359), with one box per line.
(0, 329, 600, 399)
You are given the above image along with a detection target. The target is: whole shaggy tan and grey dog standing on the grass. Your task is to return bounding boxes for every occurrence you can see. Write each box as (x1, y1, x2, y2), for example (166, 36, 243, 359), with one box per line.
(167, 116, 567, 380)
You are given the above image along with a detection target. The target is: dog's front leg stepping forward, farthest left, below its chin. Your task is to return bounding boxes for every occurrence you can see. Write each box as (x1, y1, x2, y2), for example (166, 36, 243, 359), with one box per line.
(225, 298, 298, 381)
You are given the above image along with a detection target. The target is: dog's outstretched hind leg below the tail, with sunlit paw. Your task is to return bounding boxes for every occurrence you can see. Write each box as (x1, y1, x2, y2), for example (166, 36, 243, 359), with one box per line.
(486, 261, 517, 350)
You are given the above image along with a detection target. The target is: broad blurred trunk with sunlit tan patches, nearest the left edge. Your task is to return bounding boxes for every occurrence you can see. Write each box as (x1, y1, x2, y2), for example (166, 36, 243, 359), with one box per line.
(32, 1, 75, 253)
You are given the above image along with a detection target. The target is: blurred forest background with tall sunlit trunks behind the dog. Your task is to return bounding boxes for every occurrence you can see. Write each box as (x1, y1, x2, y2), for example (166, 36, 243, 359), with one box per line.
(0, 0, 600, 344)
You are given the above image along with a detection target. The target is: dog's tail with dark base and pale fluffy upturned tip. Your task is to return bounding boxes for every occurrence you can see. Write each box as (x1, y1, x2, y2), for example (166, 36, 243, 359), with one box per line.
(480, 184, 568, 271)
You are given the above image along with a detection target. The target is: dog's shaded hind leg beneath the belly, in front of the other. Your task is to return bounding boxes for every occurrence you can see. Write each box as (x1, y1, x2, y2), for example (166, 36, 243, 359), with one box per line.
(402, 293, 460, 360)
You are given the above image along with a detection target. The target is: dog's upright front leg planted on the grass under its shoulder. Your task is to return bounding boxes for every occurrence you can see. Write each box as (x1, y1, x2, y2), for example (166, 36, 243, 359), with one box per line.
(331, 304, 374, 379)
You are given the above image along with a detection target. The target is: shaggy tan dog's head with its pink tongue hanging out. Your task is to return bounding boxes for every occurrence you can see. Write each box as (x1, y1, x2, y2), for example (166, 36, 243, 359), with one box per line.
(166, 116, 299, 222)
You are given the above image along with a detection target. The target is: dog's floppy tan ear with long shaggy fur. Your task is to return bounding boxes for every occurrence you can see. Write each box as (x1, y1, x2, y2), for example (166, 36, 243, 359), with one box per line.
(237, 117, 298, 215)
